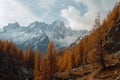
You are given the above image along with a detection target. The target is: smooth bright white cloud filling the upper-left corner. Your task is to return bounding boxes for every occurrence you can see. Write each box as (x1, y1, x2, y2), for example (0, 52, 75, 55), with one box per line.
(0, 0, 40, 27)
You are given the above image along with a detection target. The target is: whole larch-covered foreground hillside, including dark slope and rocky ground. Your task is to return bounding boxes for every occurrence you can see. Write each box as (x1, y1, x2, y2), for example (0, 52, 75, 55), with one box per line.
(0, 2, 120, 80)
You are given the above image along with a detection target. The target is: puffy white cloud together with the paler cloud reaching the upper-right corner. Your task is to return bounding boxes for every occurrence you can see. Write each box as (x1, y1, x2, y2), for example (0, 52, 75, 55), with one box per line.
(60, 0, 117, 30)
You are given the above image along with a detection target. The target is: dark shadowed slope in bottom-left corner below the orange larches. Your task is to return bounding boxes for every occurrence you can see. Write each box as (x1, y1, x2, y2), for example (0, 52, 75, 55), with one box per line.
(0, 51, 33, 80)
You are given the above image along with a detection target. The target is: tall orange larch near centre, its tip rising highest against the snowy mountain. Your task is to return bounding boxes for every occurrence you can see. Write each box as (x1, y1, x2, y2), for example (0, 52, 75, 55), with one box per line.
(45, 41, 58, 80)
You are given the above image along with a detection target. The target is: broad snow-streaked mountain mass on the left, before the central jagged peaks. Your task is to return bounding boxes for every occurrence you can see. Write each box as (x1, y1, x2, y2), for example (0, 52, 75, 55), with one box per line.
(0, 23, 49, 53)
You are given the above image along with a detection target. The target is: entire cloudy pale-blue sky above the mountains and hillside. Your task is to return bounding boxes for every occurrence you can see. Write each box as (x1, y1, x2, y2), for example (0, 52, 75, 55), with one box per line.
(0, 0, 118, 30)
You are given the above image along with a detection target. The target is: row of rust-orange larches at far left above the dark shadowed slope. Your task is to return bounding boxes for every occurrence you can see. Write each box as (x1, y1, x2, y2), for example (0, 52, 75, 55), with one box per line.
(0, 40, 35, 68)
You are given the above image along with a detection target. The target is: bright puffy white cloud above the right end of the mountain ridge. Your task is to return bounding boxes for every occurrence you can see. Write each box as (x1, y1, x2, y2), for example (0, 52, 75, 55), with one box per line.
(60, 6, 91, 30)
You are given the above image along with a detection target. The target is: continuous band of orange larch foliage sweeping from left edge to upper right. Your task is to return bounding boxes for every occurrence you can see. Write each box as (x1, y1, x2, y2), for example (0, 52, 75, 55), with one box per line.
(0, 3, 120, 80)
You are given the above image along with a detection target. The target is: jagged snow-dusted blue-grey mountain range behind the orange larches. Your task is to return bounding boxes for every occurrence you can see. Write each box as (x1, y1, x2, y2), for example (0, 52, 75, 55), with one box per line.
(0, 20, 88, 53)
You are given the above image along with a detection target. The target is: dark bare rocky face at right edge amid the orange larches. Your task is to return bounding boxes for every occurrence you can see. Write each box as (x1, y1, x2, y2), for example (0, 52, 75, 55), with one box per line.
(106, 22, 120, 53)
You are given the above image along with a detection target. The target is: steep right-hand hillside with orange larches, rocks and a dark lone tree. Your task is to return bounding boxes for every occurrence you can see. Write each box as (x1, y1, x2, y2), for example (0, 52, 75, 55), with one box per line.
(55, 2, 120, 80)
